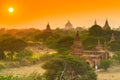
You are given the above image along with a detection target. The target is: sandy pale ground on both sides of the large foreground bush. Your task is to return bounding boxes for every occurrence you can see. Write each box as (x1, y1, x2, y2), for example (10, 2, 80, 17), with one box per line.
(0, 64, 120, 80)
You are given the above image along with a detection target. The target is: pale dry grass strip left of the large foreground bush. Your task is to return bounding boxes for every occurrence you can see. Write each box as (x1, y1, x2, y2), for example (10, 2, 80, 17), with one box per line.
(0, 63, 45, 76)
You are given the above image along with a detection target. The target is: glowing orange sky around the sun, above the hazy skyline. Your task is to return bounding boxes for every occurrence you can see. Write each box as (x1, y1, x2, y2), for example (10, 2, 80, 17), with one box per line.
(0, 0, 120, 28)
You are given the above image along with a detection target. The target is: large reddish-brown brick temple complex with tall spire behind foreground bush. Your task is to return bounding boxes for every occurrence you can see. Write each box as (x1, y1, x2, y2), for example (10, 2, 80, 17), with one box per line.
(71, 31, 109, 69)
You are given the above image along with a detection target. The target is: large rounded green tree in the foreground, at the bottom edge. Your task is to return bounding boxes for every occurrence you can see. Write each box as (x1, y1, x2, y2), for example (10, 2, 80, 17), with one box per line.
(43, 55, 97, 80)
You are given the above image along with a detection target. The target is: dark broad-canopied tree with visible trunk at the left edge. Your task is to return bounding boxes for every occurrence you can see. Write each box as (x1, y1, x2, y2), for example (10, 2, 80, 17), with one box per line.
(0, 37, 27, 59)
